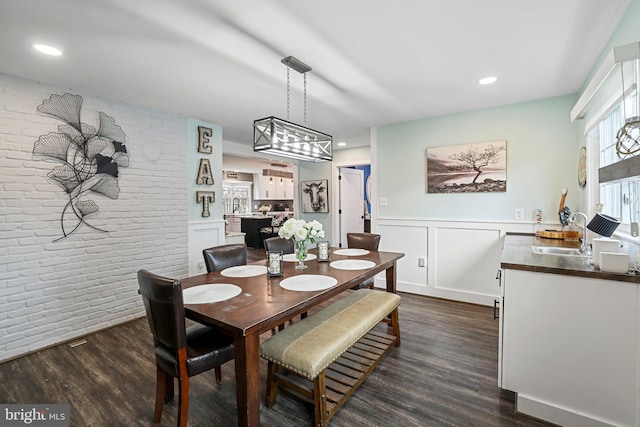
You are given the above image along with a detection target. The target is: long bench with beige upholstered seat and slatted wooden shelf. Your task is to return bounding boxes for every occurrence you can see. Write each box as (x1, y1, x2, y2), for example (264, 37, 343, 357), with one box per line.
(260, 289, 400, 427)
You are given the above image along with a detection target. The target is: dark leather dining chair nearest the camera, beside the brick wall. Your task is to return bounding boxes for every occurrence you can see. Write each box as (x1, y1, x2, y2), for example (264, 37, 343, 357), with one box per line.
(138, 270, 234, 427)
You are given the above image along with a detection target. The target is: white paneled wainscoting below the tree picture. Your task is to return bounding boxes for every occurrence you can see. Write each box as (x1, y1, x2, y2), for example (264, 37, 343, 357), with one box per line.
(372, 218, 533, 306)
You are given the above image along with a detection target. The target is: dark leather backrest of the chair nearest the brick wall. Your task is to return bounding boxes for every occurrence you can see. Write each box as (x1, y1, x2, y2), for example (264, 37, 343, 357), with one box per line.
(138, 270, 187, 358)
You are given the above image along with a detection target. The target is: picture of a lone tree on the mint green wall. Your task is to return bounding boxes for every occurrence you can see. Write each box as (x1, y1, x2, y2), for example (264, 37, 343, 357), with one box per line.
(426, 140, 507, 193)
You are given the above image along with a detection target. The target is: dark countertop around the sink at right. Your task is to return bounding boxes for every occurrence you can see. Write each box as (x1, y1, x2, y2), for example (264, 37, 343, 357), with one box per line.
(500, 233, 640, 283)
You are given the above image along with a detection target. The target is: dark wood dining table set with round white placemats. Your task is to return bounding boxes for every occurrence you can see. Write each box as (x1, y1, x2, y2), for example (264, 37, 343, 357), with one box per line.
(182, 248, 404, 427)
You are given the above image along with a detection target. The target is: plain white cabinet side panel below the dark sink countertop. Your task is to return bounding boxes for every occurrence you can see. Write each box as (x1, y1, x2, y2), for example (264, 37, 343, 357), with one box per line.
(499, 269, 640, 426)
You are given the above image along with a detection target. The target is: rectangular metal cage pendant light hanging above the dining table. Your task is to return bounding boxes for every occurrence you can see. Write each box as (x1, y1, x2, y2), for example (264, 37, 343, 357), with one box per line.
(253, 56, 333, 162)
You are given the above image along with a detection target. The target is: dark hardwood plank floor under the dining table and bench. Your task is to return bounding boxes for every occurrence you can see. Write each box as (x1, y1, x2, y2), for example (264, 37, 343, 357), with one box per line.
(0, 249, 550, 427)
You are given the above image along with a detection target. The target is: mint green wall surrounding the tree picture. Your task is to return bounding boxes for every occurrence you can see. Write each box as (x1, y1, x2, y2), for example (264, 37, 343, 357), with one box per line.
(375, 95, 579, 222)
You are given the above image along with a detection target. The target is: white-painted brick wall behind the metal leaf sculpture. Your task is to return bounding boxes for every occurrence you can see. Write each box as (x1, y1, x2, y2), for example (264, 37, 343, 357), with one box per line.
(0, 74, 188, 361)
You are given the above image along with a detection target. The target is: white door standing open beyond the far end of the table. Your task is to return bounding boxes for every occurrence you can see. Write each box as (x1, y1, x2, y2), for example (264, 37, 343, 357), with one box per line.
(338, 168, 364, 248)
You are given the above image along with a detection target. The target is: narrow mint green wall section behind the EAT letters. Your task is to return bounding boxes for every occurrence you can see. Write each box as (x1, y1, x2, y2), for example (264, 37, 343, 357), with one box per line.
(187, 118, 223, 221)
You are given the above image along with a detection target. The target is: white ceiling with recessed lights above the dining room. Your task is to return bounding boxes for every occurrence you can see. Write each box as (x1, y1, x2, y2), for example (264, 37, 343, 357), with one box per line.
(0, 0, 630, 154)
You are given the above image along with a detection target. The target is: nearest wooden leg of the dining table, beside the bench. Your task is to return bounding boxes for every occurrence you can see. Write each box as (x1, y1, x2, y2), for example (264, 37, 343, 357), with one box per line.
(234, 333, 260, 427)
